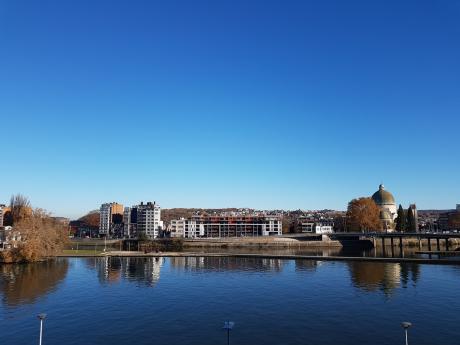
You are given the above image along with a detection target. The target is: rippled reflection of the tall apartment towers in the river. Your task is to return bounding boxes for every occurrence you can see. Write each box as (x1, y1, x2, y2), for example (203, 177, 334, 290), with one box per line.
(94, 257, 165, 286)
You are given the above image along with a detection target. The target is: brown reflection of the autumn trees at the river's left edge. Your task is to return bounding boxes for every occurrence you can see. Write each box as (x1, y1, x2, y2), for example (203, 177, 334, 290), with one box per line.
(0, 259, 69, 306)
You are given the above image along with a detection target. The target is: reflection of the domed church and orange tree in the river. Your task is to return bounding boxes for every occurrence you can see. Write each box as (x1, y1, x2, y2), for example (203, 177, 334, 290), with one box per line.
(347, 261, 420, 295)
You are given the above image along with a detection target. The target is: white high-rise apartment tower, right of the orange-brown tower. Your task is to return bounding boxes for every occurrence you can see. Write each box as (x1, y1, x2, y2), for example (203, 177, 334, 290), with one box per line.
(136, 202, 163, 239)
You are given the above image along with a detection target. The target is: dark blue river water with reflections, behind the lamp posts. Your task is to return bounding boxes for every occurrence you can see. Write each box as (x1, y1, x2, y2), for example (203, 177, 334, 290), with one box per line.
(0, 257, 460, 345)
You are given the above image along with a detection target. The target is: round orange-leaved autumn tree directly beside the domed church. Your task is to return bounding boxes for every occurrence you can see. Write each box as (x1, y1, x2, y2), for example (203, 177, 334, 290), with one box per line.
(347, 198, 383, 232)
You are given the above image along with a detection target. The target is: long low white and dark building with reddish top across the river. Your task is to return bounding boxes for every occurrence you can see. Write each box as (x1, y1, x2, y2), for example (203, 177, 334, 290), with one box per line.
(170, 215, 282, 238)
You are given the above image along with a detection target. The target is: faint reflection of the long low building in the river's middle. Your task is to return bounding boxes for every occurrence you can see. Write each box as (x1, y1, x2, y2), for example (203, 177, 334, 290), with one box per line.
(170, 256, 286, 272)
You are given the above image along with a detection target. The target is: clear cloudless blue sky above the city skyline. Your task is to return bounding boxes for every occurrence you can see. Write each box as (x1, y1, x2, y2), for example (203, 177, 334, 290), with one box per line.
(0, 0, 460, 217)
